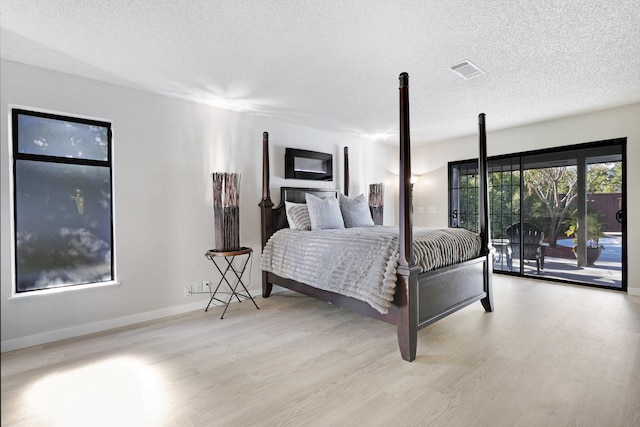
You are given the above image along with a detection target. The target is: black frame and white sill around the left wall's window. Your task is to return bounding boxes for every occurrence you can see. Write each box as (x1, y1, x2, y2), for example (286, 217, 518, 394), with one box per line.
(9, 105, 119, 299)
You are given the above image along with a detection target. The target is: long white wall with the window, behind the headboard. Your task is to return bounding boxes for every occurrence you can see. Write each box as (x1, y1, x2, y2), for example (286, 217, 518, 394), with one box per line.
(0, 60, 368, 351)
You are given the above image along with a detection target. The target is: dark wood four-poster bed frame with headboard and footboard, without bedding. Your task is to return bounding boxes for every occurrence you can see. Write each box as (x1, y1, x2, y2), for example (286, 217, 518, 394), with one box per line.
(259, 73, 493, 361)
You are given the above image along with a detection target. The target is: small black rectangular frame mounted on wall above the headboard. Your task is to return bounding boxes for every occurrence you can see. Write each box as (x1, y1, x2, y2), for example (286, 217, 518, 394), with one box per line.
(284, 148, 333, 181)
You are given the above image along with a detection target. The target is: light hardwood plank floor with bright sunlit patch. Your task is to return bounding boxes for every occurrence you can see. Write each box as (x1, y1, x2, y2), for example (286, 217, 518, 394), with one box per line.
(2, 276, 640, 426)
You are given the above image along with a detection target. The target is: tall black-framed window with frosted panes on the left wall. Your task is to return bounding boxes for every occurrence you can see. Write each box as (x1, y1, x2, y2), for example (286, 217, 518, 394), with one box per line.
(12, 109, 114, 294)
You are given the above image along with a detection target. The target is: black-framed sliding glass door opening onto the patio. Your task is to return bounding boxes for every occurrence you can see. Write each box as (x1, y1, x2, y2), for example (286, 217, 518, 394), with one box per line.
(449, 139, 626, 290)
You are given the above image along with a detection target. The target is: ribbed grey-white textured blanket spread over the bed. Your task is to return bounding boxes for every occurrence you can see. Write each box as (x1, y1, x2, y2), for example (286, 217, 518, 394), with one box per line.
(260, 226, 481, 314)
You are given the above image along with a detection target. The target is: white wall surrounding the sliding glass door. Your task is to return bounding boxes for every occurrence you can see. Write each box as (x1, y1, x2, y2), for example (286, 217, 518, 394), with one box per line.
(412, 104, 640, 295)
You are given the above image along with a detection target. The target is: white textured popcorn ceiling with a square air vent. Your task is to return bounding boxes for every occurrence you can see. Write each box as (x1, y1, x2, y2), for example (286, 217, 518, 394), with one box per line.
(0, 0, 640, 143)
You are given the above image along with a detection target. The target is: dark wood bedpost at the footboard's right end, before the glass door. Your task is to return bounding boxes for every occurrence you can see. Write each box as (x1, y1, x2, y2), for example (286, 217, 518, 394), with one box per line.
(478, 113, 493, 311)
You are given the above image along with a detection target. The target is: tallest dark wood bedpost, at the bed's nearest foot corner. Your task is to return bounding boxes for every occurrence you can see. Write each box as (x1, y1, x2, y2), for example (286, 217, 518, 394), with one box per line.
(396, 73, 419, 362)
